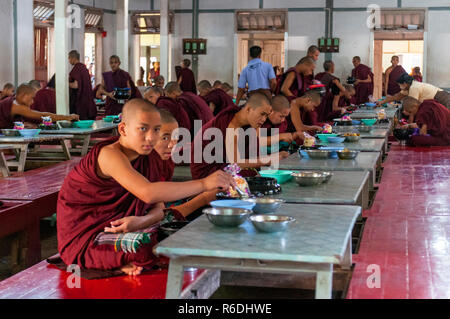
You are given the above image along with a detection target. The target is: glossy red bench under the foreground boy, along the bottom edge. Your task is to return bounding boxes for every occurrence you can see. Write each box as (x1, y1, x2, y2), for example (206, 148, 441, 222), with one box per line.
(0, 261, 220, 299)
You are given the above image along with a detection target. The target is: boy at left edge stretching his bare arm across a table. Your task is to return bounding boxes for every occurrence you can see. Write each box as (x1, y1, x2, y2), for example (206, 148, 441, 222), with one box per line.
(0, 84, 79, 129)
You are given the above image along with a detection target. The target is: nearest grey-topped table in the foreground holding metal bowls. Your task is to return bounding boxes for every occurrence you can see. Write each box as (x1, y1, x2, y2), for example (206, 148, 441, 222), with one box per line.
(154, 204, 361, 299)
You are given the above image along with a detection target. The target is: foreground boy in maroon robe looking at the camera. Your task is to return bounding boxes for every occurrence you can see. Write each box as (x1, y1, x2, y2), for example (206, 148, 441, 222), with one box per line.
(57, 99, 234, 275)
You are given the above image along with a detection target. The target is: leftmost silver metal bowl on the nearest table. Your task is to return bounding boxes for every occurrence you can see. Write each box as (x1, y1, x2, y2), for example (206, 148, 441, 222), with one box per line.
(203, 207, 252, 227)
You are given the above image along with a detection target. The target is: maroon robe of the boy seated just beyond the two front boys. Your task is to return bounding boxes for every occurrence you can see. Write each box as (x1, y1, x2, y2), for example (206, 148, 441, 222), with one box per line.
(191, 106, 259, 179)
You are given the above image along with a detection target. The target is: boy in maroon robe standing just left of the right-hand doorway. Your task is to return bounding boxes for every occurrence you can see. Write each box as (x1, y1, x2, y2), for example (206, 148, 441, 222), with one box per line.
(352, 56, 373, 104)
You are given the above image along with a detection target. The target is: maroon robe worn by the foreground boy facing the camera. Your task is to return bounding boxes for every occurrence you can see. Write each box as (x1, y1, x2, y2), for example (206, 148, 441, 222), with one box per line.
(57, 137, 159, 270)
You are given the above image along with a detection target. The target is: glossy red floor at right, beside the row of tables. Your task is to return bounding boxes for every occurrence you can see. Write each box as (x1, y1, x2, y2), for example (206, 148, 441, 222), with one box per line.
(347, 145, 450, 299)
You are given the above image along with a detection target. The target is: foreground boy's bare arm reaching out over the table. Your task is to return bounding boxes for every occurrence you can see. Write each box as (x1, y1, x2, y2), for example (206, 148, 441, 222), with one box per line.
(98, 145, 232, 204)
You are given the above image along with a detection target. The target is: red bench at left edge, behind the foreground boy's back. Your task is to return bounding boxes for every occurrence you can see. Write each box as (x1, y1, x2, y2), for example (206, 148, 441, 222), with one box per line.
(0, 158, 80, 268)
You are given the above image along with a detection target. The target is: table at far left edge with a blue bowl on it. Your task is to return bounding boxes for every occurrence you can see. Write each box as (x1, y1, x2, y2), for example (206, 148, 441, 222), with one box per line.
(0, 134, 73, 172)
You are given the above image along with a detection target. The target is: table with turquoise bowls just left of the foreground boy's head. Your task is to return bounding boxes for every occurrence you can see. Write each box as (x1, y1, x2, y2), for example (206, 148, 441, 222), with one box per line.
(41, 120, 118, 156)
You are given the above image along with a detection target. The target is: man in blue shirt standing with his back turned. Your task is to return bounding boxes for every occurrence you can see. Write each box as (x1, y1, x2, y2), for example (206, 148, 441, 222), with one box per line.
(236, 46, 277, 105)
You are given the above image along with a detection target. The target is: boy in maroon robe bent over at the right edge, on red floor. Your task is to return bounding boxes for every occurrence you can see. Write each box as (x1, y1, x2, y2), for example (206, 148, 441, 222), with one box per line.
(402, 96, 450, 146)
